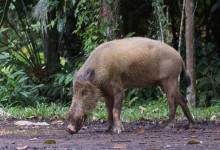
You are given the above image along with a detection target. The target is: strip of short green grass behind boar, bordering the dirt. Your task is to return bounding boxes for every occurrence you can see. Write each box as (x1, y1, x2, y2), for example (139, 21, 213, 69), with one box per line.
(3, 100, 220, 121)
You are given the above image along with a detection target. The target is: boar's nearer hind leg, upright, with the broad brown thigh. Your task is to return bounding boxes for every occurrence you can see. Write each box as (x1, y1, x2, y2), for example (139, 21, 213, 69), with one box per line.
(161, 79, 178, 128)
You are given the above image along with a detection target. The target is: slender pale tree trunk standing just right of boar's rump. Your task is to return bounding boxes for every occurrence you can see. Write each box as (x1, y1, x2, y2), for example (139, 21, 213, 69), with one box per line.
(185, 0, 196, 107)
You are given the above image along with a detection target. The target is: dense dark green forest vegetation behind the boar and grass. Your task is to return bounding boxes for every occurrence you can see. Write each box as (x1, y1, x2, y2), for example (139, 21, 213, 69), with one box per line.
(0, 0, 220, 107)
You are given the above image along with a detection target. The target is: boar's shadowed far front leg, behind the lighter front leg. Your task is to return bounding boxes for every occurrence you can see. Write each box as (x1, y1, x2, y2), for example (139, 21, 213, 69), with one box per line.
(104, 96, 114, 131)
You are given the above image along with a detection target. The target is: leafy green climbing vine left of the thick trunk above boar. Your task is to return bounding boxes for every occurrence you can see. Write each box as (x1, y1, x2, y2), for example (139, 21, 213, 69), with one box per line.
(74, 0, 102, 55)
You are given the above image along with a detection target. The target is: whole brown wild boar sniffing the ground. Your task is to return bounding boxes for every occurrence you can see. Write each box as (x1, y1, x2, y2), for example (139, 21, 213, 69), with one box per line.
(66, 37, 193, 134)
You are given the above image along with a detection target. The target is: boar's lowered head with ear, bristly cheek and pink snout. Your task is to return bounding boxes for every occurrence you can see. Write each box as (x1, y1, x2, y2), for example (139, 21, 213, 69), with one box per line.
(66, 71, 100, 134)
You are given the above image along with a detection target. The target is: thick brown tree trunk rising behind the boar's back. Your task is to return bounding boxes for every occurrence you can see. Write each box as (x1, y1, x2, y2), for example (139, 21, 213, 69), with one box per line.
(100, 0, 121, 40)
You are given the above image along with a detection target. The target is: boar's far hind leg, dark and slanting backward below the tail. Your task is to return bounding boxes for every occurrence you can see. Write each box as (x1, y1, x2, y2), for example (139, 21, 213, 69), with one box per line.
(177, 90, 194, 128)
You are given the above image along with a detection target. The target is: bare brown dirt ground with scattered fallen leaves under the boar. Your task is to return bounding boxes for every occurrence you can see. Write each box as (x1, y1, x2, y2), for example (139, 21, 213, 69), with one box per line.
(0, 119, 220, 150)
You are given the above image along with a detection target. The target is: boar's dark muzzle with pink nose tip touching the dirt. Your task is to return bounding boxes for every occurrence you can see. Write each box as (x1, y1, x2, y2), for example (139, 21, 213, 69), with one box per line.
(66, 115, 87, 134)
